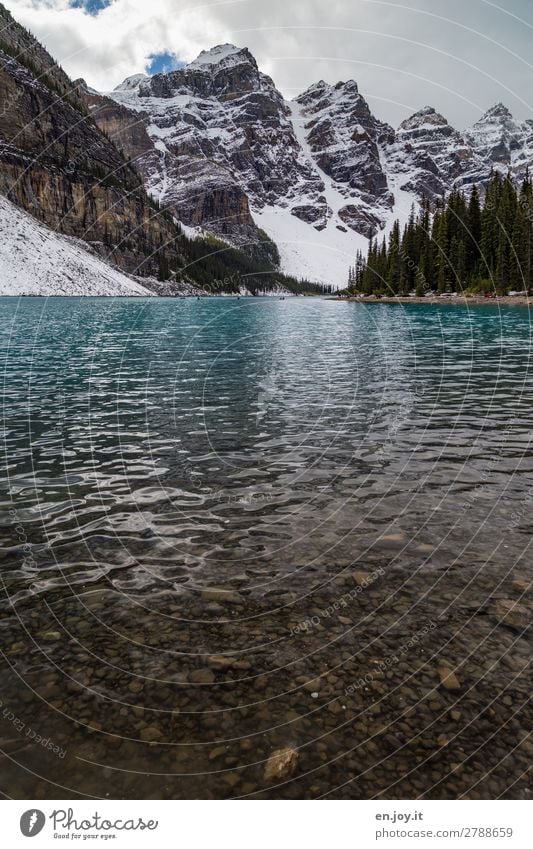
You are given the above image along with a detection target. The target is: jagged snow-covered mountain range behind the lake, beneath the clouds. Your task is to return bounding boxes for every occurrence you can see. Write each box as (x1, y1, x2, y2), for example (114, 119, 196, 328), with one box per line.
(82, 44, 533, 284)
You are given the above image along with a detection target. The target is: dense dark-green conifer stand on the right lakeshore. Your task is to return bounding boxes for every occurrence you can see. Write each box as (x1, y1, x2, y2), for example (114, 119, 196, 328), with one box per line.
(348, 173, 533, 296)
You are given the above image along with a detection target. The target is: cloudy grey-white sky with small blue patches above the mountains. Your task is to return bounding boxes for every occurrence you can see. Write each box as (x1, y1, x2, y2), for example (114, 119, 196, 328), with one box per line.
(3, 0, 533, 128)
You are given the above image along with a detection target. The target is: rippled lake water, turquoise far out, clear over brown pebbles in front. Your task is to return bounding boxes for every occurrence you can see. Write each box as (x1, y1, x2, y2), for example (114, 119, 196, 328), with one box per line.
(0, 298, 533, 798)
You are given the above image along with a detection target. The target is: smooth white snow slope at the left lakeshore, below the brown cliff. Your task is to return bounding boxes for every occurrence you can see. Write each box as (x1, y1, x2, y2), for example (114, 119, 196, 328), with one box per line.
(0, 195, 152, 296)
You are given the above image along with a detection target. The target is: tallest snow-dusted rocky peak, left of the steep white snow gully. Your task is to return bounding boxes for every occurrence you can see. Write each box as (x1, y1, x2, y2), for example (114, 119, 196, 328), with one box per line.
(100, 44, 325, 258)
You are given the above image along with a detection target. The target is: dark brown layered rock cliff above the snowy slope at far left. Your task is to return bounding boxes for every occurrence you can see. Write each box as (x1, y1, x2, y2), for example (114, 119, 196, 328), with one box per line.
(0, 1, 182, 274)
